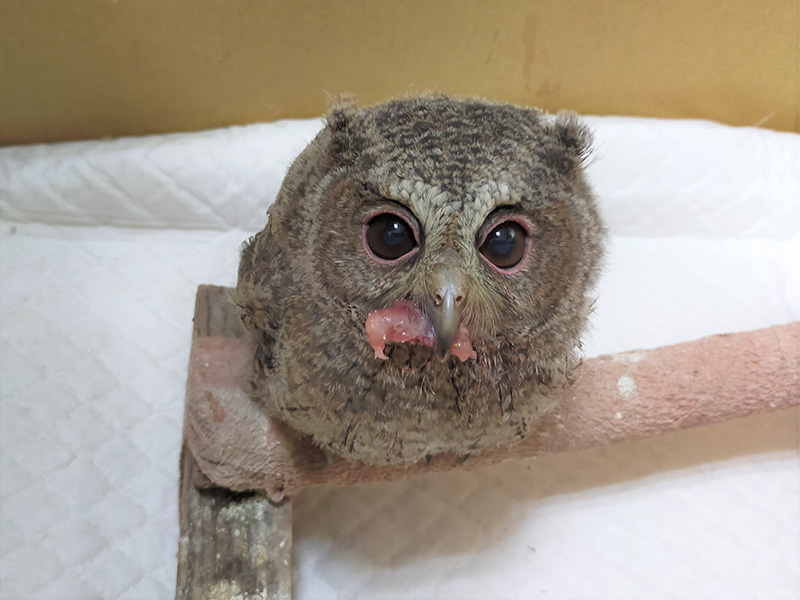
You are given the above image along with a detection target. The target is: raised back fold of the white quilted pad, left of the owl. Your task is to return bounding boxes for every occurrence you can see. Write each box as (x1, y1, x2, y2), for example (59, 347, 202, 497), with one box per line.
(0, 119, 321, 231)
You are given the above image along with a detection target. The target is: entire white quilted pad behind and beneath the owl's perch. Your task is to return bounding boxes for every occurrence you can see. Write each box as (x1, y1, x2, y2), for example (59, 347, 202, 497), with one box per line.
(0, 118, 800, 600)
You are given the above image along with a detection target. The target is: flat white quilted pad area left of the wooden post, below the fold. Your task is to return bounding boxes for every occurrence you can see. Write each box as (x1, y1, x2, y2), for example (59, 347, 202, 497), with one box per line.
(0, 224, 244, 598)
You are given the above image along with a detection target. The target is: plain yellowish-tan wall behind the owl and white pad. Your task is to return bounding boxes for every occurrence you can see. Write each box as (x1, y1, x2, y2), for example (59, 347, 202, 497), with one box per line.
(0, 0, 800, 144)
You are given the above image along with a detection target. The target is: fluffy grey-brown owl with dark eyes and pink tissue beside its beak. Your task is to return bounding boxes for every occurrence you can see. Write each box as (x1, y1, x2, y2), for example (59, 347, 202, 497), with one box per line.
(235, 95, 606, 464)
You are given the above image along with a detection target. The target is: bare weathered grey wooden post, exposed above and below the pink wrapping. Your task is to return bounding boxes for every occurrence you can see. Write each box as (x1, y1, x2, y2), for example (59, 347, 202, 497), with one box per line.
(175, 286, 292, 600)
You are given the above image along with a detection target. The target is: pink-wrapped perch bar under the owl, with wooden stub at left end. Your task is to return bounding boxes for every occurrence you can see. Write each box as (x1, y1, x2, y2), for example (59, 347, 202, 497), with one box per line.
(184, 286, 800, 501)
